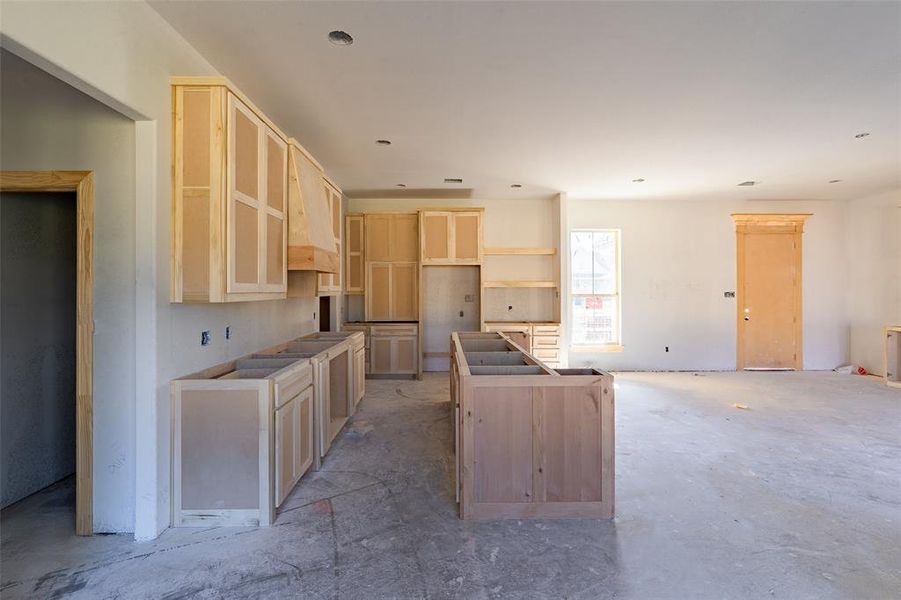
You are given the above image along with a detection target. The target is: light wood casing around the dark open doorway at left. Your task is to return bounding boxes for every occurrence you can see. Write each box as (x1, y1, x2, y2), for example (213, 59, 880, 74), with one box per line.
(0, 171, 94, 535)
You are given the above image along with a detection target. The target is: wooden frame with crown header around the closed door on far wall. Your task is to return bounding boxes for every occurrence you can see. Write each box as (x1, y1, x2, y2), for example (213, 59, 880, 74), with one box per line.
(732, 213, 811, 371)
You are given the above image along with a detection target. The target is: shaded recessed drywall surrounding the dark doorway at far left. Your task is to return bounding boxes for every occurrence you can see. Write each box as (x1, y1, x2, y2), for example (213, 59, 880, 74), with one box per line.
(0, 52, 135, 531)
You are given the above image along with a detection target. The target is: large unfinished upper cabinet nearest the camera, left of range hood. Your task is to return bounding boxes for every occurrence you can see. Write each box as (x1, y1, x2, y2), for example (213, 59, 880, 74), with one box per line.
(170, 78, 288, 302)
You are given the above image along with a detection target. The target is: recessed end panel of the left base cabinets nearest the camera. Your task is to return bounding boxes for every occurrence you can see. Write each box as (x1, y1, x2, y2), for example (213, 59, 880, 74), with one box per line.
(181, 390, 260, 510)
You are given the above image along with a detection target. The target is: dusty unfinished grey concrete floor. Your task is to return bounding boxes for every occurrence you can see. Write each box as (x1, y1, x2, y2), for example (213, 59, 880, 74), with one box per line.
(2, 373, 901, 600)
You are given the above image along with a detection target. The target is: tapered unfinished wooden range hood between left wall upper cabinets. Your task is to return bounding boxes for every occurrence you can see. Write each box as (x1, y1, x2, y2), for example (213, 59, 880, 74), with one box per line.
(288, 138, 341, 273)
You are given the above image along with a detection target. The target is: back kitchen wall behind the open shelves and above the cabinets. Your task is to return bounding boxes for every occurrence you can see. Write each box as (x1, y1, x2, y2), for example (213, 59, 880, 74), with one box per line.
(347, 197, 559, 321)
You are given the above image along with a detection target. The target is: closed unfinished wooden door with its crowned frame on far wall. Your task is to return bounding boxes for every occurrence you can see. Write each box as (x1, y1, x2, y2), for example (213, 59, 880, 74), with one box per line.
(733, 214, 808, 370)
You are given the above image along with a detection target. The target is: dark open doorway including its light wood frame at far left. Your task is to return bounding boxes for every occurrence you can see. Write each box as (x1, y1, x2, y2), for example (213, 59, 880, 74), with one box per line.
(0, 171, 94, 535)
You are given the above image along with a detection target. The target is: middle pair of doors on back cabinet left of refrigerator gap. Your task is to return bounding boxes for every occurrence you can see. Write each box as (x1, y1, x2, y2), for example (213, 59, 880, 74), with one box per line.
(365, 261, 419, 321)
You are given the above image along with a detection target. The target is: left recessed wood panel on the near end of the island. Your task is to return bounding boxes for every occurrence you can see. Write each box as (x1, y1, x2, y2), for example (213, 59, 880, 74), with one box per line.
(472, 387, 532, 502)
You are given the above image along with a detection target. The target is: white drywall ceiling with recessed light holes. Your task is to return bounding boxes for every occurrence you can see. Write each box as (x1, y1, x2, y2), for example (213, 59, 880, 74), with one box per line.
(151, 0, 901, 199)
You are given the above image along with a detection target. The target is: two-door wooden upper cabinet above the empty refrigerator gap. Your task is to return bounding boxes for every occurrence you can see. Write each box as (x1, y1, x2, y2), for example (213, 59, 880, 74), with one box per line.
(419, 210, 482, 265)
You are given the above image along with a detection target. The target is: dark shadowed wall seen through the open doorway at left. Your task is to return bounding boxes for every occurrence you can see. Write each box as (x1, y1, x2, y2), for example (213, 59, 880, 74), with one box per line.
(0, 191, 76, 507)
